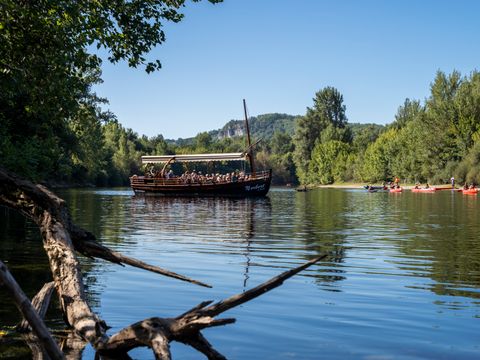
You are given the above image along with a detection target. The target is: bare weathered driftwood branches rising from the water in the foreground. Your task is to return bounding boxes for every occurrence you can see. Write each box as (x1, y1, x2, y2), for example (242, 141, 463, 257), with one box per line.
(0, 167, 326, 359)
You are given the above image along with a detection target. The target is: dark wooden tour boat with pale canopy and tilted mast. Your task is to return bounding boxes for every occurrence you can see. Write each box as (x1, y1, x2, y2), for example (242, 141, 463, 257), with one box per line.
(130, 100, 272, 197)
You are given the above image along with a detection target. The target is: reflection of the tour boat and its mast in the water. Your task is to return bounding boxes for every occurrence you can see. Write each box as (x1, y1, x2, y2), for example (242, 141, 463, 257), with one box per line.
(131, 196, 272, 291)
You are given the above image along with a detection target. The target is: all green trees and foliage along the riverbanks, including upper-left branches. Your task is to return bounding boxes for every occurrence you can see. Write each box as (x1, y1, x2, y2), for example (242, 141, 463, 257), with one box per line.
(0, 0, 480, 191)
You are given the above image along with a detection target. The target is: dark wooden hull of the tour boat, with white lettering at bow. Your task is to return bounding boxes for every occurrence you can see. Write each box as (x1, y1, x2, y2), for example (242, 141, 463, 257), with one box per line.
(130, 170, 272, 197)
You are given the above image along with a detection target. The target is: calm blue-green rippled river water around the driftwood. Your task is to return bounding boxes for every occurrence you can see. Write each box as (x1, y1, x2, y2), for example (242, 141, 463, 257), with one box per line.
(0, 188, 480, 360)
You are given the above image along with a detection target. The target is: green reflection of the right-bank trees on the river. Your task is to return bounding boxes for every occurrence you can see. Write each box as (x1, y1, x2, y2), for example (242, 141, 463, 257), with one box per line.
(340, 192, 480, 298)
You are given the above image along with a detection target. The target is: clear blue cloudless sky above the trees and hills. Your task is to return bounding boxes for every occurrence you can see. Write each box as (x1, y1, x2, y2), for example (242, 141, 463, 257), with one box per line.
(96, 0, 480, 139)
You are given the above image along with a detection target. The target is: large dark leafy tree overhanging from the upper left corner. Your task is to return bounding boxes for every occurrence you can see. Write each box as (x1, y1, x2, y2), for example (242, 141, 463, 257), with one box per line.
(0, 0, 220, 179)
